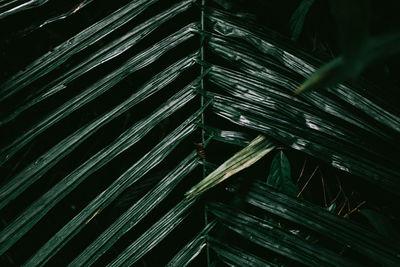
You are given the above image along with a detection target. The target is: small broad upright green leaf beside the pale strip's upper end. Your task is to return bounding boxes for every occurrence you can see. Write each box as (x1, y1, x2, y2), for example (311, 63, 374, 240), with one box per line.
(267, 151, 299, 197)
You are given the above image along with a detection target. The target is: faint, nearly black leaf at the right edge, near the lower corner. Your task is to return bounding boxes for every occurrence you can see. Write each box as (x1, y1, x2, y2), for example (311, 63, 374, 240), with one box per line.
(359, 209, 400, 241)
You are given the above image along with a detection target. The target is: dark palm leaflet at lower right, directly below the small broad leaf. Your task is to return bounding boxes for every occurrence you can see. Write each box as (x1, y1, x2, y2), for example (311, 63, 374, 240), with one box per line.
(234, 182, 399, 266)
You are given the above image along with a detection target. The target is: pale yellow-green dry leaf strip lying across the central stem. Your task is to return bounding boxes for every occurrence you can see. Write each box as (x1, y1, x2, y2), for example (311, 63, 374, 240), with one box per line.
(185, 135, 275, 198)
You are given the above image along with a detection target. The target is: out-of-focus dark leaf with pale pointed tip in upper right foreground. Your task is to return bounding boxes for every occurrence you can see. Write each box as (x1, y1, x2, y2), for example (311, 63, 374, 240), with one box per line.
(294, 0, 400, 94)
